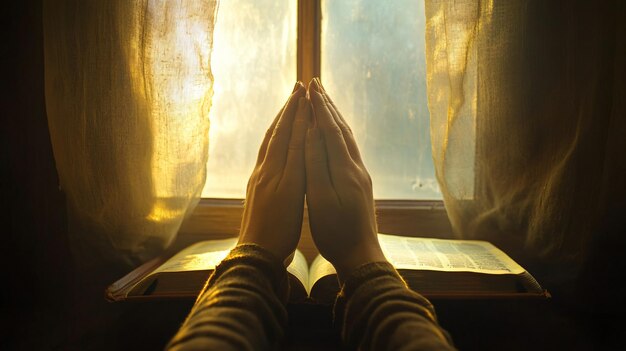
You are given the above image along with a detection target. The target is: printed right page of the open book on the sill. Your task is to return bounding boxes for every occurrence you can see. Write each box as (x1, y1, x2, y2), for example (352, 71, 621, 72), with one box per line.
(378, 234, 525, 274)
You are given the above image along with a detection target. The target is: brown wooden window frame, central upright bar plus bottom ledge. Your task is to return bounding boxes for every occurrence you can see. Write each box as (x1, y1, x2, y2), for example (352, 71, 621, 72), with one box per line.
(174, 0, 453, 261)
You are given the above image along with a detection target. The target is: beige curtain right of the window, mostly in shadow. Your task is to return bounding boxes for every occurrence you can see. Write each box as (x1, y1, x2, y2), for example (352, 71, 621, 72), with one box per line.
(426, 0, 626, 257)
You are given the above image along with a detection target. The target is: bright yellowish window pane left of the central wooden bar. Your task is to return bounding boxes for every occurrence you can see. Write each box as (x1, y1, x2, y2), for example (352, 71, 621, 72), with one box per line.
(202, 0, 297, 198)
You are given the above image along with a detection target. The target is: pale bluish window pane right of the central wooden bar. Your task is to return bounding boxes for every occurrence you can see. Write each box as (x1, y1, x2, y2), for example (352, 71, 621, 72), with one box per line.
(321, 0, 441, 199)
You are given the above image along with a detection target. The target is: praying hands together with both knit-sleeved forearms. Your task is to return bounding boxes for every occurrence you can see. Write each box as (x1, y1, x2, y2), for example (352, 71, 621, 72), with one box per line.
(167, 79, 454, 350)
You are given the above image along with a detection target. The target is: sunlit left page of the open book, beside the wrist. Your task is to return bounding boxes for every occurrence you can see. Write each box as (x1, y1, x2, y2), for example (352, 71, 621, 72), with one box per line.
(151, 238, 238, 274)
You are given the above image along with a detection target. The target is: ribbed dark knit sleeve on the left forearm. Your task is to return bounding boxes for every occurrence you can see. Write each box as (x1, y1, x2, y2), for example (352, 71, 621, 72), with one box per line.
(166, 244, 289, 351)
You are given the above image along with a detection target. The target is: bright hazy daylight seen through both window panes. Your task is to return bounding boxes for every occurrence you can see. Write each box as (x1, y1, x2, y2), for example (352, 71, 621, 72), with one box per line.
(202, 0, 441, 199)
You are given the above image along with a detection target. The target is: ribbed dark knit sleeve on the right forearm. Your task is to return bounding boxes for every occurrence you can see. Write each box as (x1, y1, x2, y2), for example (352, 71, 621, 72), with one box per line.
(334, 262, 455, 350)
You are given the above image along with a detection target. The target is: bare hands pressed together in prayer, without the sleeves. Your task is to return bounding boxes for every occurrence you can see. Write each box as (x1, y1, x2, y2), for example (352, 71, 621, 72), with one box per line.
(239, 78, 385, 279)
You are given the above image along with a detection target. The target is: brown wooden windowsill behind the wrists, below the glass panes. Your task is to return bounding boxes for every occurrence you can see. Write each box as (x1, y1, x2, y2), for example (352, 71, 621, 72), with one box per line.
(176, 198, 452, 262)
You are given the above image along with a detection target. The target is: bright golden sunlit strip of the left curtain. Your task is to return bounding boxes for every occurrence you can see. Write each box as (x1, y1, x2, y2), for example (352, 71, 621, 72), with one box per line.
(138, 0, 212, 206)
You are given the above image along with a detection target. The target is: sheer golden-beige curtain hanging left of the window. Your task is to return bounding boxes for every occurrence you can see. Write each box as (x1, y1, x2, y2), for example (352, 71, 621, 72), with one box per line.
(43, 0, 217, 264)
